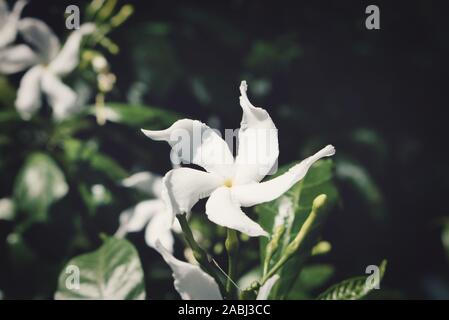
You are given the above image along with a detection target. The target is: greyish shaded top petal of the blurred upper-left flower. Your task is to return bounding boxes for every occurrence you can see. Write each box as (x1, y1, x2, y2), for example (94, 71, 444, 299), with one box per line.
(19, 18, 61, 63)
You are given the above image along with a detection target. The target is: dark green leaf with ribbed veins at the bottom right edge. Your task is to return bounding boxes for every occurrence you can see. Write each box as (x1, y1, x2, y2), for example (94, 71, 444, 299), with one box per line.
(317, 260, 387, 300)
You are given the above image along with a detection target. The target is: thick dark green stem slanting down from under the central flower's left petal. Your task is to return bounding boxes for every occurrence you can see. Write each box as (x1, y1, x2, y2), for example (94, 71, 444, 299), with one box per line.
(176, 214, 226, 293)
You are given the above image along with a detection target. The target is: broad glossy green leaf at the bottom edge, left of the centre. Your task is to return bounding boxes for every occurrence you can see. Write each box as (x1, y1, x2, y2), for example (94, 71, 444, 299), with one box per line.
(55, 237, 145, 300)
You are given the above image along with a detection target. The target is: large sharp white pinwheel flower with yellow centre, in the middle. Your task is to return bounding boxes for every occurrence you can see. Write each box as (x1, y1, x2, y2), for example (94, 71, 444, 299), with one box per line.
(142, 81, 335, 236)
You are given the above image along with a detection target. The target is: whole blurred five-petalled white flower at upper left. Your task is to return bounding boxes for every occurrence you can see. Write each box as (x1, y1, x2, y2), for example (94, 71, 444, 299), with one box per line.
(0, 18, 95, 120)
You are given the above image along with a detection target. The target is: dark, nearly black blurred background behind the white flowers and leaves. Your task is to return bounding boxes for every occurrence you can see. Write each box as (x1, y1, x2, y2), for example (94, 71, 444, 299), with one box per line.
(0, 0, 449, 299)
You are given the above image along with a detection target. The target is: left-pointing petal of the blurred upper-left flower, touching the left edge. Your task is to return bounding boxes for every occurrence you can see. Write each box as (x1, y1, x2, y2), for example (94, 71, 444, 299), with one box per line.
(0, 44, 38, 74)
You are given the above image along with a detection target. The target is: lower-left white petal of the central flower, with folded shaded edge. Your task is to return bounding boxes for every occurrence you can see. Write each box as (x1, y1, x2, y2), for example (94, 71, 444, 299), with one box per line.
(162, 168, 223, 221)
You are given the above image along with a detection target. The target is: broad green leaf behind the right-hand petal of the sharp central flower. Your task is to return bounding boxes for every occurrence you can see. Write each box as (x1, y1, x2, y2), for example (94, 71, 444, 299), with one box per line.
(256, 159, 338, 298)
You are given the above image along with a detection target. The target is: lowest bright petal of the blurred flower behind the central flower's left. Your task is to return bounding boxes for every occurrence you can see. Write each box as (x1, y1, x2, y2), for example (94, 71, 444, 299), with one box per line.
(145, 211, 175, 253)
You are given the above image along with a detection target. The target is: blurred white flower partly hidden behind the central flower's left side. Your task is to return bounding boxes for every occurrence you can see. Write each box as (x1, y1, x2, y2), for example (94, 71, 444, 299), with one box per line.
(116, 172, 181, 252)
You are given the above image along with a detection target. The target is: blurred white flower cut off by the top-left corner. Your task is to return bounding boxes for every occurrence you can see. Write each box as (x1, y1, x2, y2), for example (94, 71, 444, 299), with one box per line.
(0, 0, 27, 49)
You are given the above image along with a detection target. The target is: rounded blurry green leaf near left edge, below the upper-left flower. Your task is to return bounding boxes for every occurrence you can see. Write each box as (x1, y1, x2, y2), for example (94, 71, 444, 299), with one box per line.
(14, 153, 69, 220)
